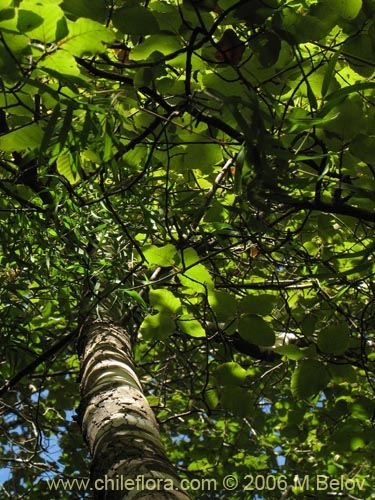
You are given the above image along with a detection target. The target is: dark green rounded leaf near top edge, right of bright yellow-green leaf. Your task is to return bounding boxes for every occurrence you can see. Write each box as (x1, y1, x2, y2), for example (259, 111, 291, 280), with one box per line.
(113, 6, 159, 36)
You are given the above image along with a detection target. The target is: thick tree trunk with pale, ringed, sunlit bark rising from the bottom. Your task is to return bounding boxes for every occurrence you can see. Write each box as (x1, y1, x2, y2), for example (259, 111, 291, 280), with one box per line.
(78, 321, 189, 500)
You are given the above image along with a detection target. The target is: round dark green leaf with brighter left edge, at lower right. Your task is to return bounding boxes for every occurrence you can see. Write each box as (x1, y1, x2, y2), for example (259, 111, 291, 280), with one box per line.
(290, 359, 330, 399)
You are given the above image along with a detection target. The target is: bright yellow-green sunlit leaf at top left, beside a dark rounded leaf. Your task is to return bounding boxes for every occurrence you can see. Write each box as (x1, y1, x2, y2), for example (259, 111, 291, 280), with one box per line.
(60, 18, 115, 57)
